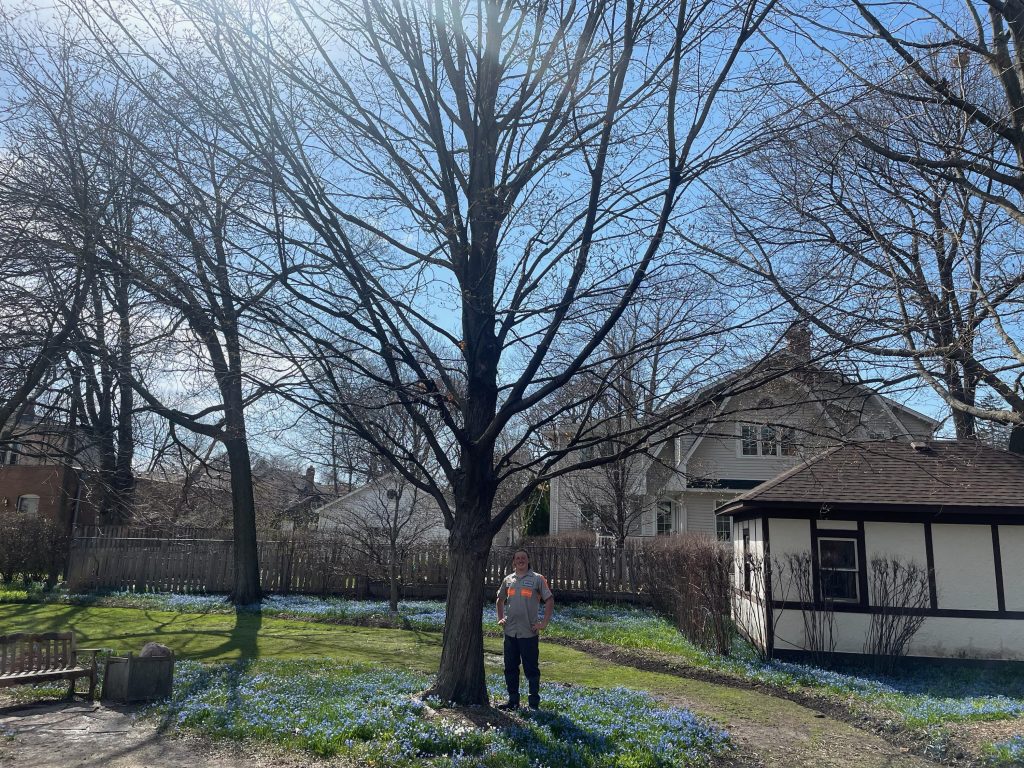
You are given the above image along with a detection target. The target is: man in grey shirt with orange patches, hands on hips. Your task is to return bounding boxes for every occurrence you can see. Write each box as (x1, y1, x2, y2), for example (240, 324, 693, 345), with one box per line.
(495, 549, 555, 710)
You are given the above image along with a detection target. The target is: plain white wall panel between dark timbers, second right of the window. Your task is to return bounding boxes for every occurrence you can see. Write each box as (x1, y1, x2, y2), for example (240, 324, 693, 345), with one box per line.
(932, 525, 998, 621)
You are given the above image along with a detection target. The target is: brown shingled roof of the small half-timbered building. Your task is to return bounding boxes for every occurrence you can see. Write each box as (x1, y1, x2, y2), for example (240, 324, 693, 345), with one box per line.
(718, 440, 1024, 516)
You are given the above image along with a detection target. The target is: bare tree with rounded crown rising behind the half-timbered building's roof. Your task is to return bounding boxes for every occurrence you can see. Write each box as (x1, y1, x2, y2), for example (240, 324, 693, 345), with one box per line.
(719, 85, 1024, 438)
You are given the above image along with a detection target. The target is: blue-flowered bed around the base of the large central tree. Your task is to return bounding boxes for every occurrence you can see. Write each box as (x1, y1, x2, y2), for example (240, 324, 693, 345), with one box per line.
(152, 660, 732, 768)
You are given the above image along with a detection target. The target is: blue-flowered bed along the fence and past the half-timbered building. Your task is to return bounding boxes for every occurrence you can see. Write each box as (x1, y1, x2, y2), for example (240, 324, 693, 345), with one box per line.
(0, 593, 1024, 765)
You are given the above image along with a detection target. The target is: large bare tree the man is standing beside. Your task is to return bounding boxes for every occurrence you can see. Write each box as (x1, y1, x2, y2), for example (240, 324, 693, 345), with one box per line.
(83, 0, 773, 703)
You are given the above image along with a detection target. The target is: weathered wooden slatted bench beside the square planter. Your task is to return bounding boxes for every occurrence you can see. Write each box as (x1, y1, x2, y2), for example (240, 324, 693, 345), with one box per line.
(0, 632, 98, 699)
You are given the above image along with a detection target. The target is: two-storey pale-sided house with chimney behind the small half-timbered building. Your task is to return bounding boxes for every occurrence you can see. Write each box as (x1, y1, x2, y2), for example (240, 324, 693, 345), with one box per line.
(549, 327, 938, 541)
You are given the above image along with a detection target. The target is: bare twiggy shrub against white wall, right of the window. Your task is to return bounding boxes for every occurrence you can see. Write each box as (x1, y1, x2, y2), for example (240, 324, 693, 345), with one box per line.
(864, 556, 931, 673)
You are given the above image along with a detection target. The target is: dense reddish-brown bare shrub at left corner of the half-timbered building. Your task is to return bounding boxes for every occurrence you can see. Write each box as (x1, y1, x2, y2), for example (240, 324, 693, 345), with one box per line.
(635, 534, 734, 653)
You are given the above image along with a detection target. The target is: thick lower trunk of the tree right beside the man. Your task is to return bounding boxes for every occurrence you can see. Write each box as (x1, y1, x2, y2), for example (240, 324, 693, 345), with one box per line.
(430, 516, 490, 706)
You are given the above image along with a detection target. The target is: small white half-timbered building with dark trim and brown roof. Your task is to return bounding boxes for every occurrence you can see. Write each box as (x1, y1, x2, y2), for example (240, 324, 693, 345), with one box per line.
(720, 440, 1024, 660)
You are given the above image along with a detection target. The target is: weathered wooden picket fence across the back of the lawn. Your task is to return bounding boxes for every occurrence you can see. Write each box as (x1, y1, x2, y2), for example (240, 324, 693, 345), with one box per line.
(67, 527, 646, 602)
